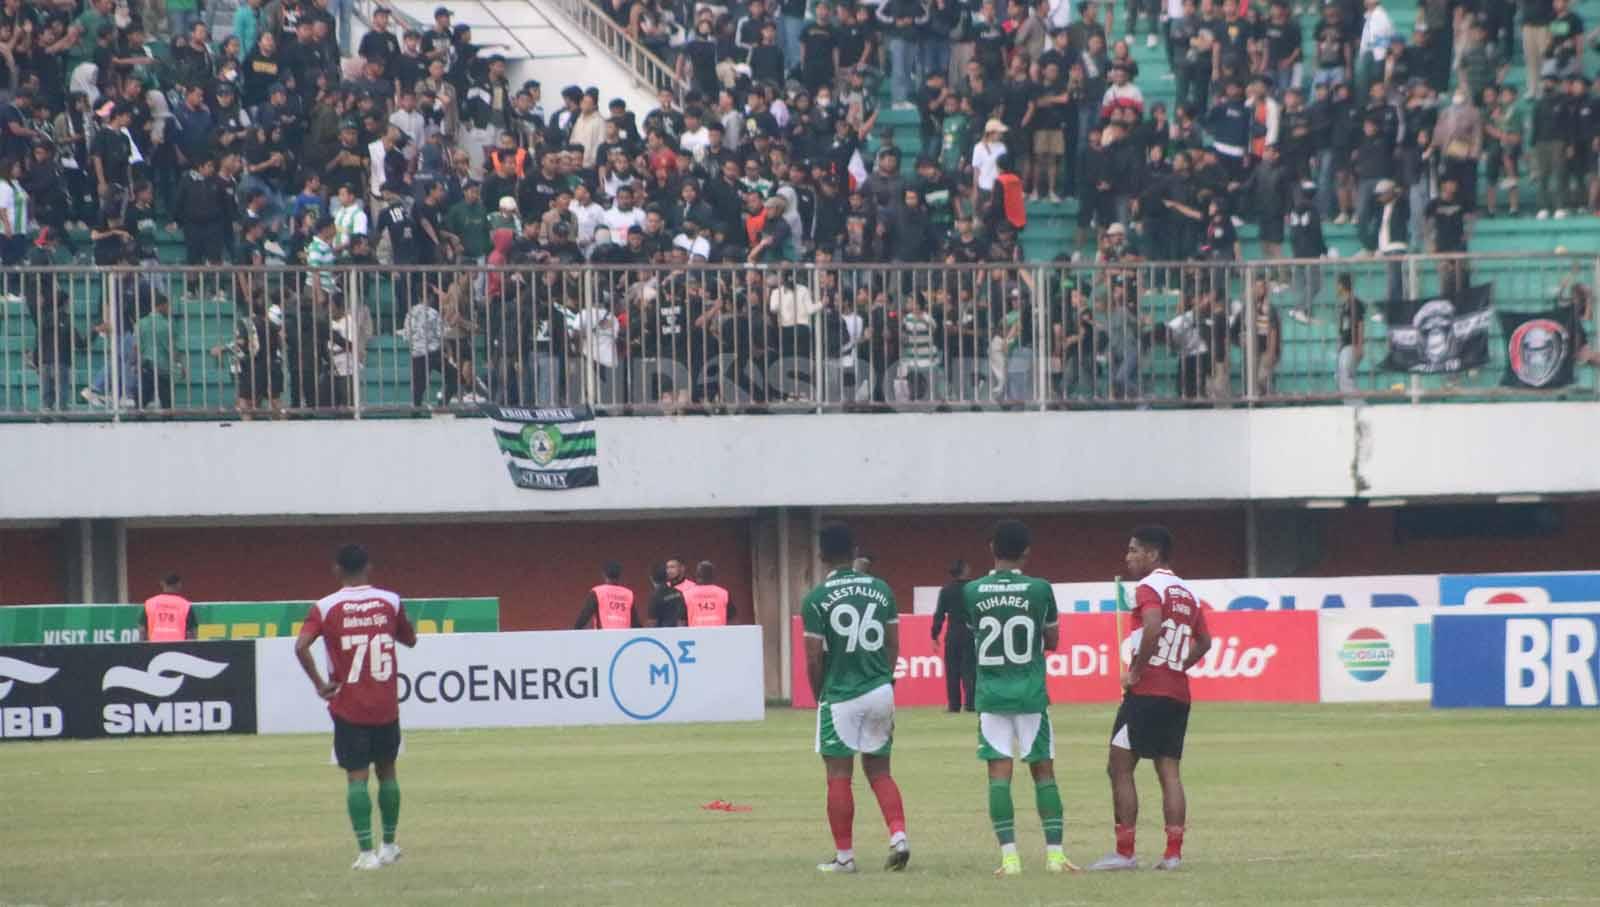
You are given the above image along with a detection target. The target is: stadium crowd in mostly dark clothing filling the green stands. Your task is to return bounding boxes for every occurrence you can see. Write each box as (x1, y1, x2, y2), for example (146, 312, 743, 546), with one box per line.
(0, 0, 1600, 408)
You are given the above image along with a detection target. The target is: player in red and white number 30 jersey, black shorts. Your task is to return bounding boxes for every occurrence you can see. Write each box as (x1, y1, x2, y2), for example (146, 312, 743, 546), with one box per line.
(1090, 526, 1211, 870)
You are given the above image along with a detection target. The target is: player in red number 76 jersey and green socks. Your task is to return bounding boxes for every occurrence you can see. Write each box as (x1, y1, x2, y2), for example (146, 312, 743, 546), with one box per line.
(294, 545, 416, 869)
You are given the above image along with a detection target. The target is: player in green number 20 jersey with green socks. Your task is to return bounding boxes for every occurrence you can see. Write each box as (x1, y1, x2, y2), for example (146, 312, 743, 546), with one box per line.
(963, 520, 1077, 875)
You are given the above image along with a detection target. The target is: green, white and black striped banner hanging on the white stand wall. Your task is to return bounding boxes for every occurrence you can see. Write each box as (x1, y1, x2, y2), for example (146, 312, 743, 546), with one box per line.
(483, 406, 600, 491)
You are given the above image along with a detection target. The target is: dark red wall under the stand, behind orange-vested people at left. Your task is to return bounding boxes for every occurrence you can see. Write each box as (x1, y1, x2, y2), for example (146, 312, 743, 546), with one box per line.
(128, 518, 750, 630)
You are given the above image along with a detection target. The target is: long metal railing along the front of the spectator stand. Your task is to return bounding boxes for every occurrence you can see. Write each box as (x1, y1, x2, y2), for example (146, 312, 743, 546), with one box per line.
(0, 256, 1600, 419)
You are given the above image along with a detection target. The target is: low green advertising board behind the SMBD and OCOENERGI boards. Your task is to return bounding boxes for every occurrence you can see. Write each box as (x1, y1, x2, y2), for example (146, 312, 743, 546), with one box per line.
(0, 598, 499, 646)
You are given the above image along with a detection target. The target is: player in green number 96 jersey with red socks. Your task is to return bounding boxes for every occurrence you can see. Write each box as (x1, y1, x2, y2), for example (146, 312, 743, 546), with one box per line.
(800, 526, 910, 872)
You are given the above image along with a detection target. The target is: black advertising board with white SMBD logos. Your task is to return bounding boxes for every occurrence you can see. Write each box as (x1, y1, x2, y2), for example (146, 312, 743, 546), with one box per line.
(0, 641, 256, 741)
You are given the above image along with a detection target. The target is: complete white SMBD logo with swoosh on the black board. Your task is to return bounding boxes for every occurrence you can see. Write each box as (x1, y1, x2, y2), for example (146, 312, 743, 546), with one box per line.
(101, 653, 234, 734)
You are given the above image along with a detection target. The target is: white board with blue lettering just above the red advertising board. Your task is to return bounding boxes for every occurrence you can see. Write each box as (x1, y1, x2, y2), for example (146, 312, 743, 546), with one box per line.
(912, 574, 1438, 614)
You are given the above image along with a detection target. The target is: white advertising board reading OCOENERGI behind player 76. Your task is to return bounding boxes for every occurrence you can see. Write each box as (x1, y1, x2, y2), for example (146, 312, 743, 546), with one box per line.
(256, 625, 765, 734)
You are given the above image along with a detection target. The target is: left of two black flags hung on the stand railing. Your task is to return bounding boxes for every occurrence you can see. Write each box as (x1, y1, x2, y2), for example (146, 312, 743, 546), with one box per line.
(1384, 283, 1494, 374)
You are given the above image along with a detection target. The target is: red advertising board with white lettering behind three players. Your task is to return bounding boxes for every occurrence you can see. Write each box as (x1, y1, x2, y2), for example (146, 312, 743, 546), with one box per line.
(790, 613, 1318, 709)
